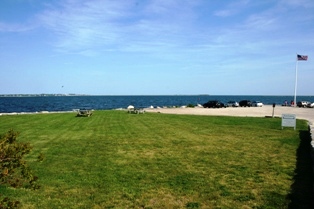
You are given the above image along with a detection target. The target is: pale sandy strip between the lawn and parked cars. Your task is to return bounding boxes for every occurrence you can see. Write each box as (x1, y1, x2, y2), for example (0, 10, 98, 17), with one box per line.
(145, 105, 314, 123)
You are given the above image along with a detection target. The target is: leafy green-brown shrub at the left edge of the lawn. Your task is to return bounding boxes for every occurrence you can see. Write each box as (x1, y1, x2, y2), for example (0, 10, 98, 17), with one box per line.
(0, 129, 39, 209)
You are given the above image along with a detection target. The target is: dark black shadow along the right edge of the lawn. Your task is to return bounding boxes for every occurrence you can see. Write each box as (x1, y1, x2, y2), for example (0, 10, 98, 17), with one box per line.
(288, 131, 314, 209)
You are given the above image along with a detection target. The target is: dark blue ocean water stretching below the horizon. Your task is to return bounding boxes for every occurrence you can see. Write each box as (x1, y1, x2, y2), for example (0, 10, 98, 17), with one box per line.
(0, 95, 314, 113)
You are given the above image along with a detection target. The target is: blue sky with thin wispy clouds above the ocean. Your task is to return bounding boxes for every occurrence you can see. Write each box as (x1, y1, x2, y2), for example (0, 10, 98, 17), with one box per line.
(0, 0, 314, 95)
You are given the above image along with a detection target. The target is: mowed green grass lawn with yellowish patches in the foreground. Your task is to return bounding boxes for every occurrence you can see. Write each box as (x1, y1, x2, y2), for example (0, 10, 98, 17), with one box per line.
(0, 110, 307, 209)
